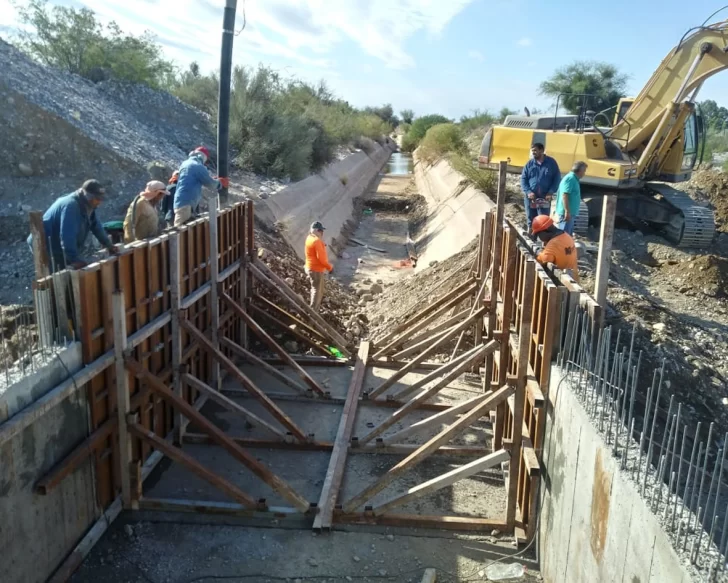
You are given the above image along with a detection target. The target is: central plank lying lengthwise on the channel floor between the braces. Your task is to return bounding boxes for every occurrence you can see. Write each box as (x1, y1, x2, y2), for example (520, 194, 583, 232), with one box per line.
(313, 341, 369, 530)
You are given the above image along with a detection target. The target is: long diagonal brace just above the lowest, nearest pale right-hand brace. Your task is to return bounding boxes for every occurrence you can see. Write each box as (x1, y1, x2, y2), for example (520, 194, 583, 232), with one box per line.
(344, 386, 514, 512)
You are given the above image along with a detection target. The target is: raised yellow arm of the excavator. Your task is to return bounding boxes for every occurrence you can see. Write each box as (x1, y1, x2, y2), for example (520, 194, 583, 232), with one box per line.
(610, 20, 728, 180)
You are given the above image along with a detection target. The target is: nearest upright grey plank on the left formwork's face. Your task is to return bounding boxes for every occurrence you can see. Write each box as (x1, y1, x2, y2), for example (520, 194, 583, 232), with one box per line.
(113, 291, 133, 508)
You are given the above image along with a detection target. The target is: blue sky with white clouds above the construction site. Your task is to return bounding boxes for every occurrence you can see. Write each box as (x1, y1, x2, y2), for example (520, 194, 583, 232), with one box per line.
(0, 0, 728, 119)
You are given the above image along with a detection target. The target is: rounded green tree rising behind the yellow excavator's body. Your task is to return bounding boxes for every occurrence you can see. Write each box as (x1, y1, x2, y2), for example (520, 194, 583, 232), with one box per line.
(540, 61, 629, 113)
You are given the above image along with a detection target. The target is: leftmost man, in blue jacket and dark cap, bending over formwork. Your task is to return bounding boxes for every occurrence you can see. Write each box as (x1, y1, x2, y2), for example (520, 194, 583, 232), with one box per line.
(28, 180, 116, 271)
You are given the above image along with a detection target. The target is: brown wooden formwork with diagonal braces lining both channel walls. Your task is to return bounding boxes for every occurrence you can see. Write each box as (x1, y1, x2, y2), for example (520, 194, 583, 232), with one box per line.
(21, 168, 598, 583)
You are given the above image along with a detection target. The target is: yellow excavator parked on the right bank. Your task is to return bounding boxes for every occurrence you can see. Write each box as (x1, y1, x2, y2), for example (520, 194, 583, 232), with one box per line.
(478, 20, 728, 247)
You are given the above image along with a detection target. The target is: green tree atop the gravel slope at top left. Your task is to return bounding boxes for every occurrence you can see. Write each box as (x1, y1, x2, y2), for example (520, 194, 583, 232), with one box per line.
(16, 0, 174, 88)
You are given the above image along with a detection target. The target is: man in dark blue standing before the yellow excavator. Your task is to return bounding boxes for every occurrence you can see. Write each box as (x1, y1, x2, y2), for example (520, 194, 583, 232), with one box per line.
(521, 142, 561, 231)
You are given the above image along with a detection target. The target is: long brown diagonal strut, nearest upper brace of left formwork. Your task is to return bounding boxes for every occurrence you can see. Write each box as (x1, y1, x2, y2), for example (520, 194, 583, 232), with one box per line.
(126, 358, 310, 512)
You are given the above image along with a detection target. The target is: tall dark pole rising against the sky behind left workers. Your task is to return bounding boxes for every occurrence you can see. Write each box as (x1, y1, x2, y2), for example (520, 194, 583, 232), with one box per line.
(217, 0, 238, 201)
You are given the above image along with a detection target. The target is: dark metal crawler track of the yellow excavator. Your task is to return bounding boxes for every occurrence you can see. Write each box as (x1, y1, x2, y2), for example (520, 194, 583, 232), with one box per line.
(649, 183, 715, 248)
